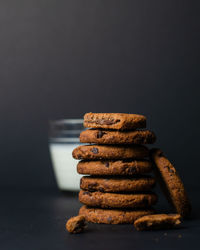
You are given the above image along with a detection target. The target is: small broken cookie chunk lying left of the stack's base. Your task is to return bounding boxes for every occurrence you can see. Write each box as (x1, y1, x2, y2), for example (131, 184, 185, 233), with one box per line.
(66, 215, 86, 234)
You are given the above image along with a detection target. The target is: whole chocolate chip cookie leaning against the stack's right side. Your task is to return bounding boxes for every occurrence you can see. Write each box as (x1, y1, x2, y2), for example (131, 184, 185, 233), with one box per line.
(151, 149, 191, 217)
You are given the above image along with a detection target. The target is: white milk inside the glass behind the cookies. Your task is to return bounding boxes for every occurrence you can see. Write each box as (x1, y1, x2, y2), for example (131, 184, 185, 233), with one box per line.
(49, 142, 82, 191)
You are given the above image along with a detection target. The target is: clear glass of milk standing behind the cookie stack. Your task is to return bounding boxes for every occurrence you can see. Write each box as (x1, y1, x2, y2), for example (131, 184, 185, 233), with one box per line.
(49, 119, 84, 191)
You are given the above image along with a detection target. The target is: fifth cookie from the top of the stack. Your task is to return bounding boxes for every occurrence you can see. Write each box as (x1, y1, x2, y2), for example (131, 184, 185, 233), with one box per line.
(80, 176, 155, 193)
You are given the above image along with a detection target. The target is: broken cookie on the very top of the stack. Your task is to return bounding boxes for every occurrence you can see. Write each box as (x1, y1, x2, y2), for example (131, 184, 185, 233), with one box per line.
(84, 113, 146, 130)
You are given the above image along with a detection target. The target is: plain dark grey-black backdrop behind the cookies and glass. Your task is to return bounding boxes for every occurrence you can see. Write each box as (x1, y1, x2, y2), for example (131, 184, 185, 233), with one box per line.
(0, 0, 200, 248)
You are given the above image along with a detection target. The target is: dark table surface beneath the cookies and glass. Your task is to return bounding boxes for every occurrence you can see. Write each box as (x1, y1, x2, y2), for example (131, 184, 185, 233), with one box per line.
(0, 188, 200, 250)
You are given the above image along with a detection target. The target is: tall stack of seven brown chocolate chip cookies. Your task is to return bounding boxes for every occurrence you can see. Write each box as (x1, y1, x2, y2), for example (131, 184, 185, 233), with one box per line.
(73, 113, 157, 224)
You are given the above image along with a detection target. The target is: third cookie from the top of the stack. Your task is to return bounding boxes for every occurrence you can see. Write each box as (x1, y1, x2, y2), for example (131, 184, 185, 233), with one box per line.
(72, 145, 149, 160)
